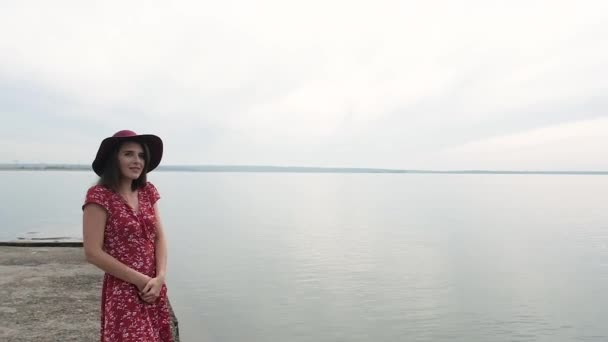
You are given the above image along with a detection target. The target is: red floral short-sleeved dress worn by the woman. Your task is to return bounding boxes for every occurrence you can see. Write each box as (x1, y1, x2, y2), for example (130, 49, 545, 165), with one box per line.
(83, 183, 172, 342)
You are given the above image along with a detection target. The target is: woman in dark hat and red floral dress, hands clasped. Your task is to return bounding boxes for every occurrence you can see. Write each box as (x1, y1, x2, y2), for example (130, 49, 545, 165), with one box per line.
(82, 130, 172, 342)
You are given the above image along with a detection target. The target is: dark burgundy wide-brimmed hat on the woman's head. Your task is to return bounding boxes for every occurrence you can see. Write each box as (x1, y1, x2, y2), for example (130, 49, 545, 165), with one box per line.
(93, 130, 163, 176)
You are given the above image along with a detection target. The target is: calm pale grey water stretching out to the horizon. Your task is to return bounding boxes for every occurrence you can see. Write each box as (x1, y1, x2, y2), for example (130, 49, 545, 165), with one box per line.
(0, 171, 608, 342)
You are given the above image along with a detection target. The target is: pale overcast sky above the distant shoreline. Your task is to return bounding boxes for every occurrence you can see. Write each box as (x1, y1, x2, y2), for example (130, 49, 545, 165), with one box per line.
(0, 0, 608, 170)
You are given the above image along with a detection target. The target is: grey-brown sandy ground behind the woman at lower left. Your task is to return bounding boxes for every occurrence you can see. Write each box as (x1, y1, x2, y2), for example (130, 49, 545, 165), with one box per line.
(0, 246, 179, 342)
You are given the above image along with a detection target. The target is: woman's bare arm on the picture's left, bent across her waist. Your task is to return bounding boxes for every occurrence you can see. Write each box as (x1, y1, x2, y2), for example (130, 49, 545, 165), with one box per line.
(82, 203, 150, 290)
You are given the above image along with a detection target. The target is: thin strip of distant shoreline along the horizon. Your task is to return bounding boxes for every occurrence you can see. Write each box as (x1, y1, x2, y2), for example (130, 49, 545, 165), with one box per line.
(0, 164, 608, 175)
